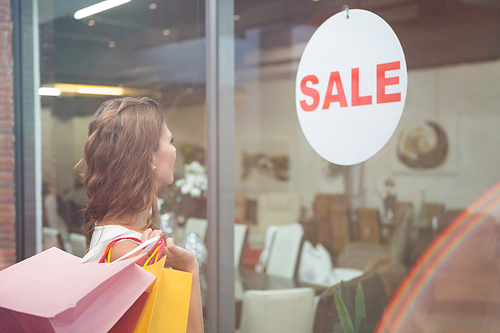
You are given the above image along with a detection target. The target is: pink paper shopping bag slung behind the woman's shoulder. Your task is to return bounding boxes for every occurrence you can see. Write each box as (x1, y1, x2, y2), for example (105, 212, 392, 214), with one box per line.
(0, 248, 156, 333)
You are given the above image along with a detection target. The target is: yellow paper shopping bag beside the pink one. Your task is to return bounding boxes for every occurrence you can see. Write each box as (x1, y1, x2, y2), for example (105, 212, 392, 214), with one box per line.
(134, 257, 193, 333)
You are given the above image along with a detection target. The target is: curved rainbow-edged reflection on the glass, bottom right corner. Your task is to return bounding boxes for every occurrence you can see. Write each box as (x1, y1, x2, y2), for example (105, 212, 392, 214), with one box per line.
(377, 183, 500, 332)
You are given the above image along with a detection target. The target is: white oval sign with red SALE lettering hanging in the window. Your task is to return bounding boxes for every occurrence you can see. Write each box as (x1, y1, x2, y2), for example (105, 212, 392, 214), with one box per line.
(295, 9, 407, 165)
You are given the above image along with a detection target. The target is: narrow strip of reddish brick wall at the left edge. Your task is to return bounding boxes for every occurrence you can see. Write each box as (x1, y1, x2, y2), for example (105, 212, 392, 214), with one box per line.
(0, 0, 16, 269)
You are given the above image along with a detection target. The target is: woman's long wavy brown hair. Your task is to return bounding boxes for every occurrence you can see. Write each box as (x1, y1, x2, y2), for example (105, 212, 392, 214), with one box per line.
(74, 97, 164, 235)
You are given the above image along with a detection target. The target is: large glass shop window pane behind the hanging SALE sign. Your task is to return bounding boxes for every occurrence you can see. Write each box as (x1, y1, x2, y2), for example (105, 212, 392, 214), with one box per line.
(234, 1, 500, 332)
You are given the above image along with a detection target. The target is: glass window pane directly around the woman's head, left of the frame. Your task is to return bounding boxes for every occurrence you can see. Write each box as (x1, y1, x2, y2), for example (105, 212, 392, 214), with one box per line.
(38, 1, 206, 255)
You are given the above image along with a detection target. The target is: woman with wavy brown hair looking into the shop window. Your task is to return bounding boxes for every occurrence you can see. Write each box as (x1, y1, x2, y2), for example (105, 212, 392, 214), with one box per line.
(75, 97, 204, 333)
